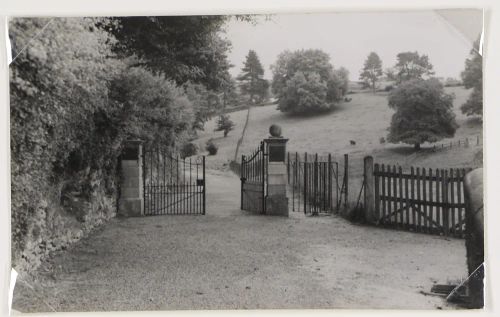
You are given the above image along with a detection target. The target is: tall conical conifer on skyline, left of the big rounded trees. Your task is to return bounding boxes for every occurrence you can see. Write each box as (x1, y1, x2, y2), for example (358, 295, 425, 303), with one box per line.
(237, 50, 269, 104)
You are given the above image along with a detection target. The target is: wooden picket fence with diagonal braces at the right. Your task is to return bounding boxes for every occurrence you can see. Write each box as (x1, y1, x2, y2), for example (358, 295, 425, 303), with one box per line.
(373, 164, 469, 237)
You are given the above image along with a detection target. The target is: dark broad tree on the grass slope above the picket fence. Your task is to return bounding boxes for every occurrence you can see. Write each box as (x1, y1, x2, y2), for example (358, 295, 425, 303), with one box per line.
(388, 79, 458, 150)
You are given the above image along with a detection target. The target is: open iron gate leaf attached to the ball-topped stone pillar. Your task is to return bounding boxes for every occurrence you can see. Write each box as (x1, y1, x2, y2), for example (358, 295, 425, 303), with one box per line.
(240, 142, 267, 213)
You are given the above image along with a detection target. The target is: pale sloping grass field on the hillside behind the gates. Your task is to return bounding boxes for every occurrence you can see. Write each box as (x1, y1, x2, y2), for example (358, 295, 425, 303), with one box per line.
(194, 87, 482, 205)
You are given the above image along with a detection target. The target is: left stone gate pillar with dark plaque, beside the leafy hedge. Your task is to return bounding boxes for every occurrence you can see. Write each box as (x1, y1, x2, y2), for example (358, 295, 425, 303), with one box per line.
(118, 141, 144, 217)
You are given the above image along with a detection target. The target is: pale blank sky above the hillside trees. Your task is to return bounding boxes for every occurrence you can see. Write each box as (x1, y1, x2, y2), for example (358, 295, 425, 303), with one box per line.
(225, 11, 482, 81)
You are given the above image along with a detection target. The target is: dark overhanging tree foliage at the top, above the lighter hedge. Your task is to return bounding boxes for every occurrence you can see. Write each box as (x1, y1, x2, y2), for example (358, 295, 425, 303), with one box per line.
(101, 15, 230, 90)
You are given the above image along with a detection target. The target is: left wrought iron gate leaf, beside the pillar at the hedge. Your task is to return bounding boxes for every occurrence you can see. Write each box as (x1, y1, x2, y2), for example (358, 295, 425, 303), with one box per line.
(142, 149, 206, 216)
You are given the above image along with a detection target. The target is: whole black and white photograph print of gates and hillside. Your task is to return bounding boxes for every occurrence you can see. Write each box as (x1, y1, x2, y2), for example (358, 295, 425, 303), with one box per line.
(7, 8, 491, 313)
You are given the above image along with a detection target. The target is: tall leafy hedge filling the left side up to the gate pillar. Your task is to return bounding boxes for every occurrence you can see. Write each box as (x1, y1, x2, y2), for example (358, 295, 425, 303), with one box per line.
(9, 18, 203, 267)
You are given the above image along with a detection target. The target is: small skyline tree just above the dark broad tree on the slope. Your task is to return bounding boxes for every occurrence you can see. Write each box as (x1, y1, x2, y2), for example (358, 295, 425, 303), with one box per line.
(394, 52, 434, 84)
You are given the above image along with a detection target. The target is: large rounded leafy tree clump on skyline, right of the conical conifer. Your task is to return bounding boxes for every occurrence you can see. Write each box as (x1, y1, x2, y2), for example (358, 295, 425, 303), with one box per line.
(271, 50, 348, 113)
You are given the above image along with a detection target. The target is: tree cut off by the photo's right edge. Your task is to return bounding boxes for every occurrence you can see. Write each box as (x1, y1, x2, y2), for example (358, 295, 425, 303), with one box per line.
(460, 40, 483, 116)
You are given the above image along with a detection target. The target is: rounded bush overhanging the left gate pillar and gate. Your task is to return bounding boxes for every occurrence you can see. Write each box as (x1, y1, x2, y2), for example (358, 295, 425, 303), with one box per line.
(110, 67, 194, 148)
